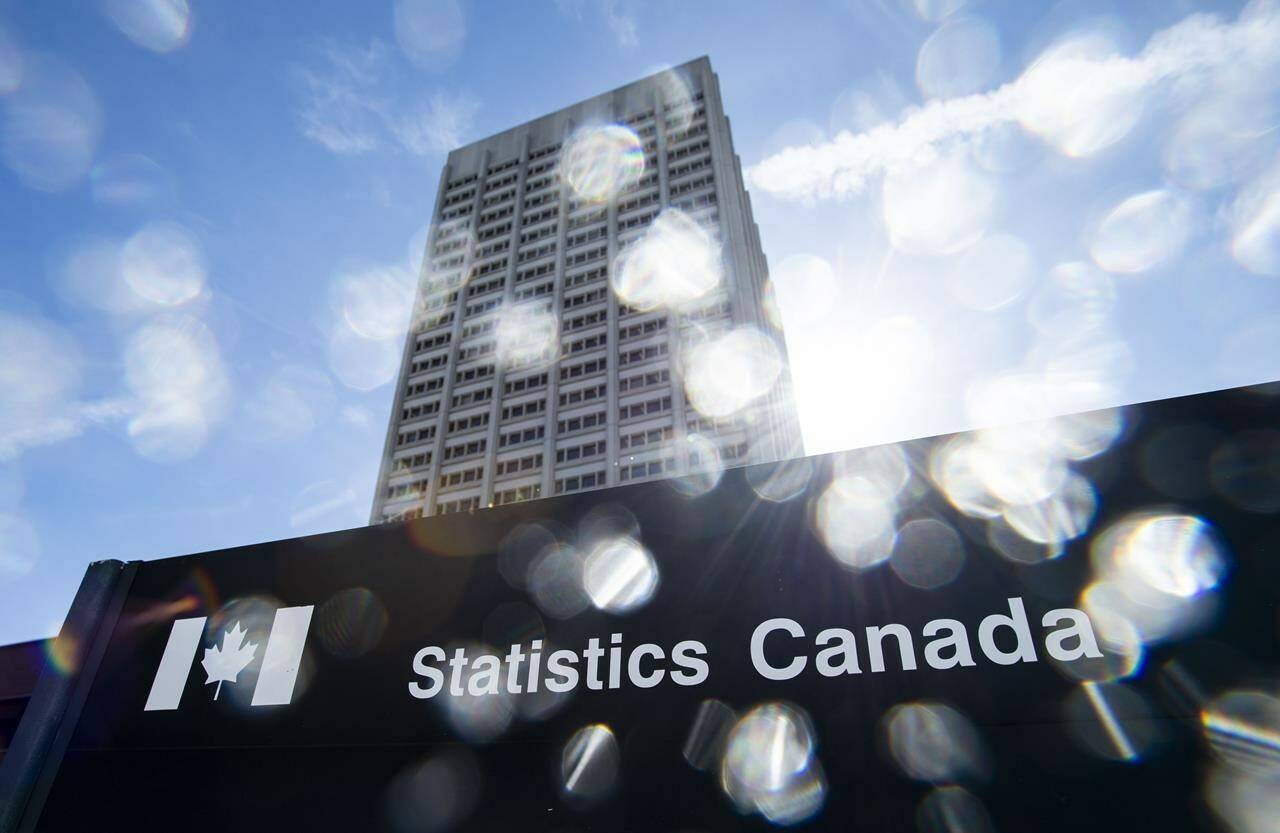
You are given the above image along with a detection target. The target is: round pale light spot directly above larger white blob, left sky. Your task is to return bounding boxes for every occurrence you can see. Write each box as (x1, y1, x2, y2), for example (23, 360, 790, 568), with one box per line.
(120, 223, 205, 306)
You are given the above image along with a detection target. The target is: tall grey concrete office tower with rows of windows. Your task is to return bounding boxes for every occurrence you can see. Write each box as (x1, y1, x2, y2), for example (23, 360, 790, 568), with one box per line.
(372, 58, 801, 523)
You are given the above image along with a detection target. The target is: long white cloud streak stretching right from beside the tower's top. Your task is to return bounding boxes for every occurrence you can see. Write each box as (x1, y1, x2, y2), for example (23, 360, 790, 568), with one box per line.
(748, 0, 1280, 201)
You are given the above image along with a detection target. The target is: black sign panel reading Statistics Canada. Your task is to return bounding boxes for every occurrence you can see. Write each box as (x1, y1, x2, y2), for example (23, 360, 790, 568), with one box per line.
(10, 390, 1280, 832)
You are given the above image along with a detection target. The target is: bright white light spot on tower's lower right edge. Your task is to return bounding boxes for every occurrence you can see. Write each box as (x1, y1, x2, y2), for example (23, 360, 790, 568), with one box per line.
(684, 326, 782, 417)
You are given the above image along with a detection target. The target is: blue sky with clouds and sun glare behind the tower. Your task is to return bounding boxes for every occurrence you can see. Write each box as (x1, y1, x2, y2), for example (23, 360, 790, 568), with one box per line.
(0, 0, 1280, 642)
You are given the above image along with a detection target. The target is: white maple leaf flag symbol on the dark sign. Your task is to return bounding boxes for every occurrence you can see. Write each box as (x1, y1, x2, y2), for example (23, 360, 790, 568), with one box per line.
(143, 604, 315, 711)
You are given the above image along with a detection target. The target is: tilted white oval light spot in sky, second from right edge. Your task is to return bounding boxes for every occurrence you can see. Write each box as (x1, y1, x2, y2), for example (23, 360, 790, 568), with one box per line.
(1089, 191, 1192, 274)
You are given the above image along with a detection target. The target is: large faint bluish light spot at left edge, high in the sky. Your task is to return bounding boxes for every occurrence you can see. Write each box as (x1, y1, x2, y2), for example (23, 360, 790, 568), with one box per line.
(0, 55, 102, 192)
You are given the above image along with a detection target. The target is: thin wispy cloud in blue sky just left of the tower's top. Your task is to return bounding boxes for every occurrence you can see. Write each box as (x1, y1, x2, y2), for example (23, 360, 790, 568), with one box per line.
(297, 38, 480, 156)
